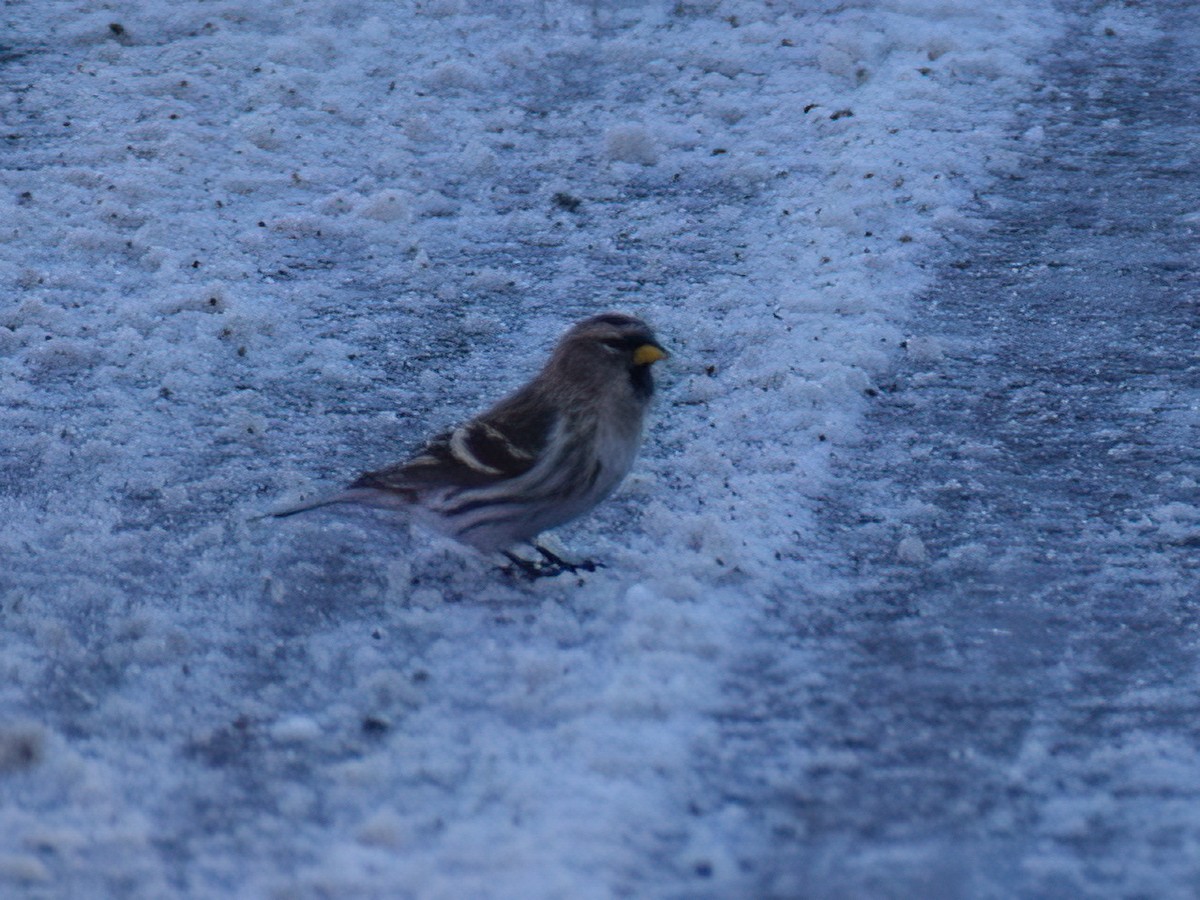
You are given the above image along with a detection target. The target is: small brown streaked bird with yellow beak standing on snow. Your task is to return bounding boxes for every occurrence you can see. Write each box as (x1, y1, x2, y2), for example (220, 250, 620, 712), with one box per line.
(269, 312, 668, 577)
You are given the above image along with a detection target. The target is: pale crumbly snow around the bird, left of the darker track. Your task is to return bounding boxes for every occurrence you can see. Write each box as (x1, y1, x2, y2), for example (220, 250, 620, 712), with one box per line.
(0, 0, 1065, 898)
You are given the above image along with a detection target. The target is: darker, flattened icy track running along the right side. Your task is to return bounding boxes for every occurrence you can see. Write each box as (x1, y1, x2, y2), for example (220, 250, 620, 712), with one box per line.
(722, 4, 1200, 896)
